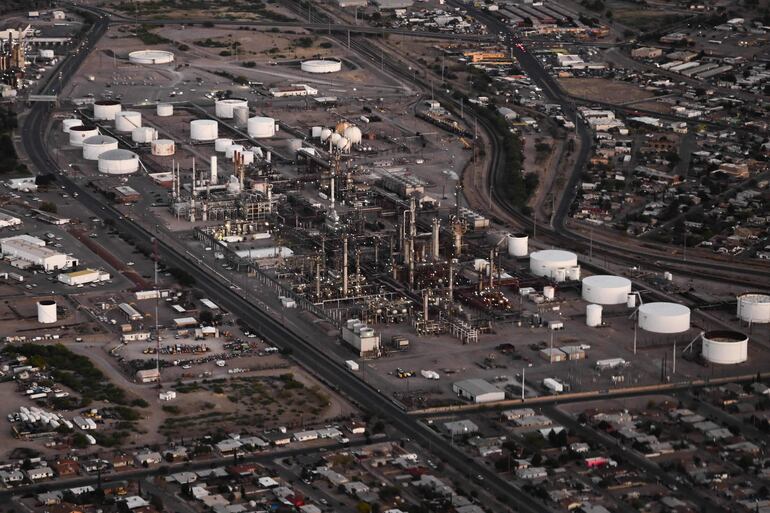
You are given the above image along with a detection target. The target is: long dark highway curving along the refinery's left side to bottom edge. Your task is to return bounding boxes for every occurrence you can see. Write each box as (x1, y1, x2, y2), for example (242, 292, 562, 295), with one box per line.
(21, 8, 551, 513)
